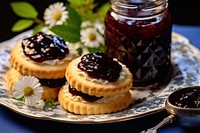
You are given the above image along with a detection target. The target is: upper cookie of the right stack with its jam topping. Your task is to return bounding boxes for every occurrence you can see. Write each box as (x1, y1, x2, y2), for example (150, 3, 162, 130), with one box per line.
(65, 52, 133, 96)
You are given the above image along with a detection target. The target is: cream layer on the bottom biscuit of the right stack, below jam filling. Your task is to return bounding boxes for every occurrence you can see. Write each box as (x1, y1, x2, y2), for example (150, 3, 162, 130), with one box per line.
(63, 85, 125, 103)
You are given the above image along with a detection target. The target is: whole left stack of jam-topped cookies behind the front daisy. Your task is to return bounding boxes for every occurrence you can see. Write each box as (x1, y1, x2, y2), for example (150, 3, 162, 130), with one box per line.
(6, 32, 78, 99)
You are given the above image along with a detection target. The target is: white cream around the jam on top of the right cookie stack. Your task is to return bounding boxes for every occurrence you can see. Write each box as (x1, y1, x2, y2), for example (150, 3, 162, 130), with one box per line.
(75, 59, 127, 85)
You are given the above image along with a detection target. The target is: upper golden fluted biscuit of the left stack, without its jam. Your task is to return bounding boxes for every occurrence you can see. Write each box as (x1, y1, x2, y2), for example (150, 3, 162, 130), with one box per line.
(10, 43, 78, 79)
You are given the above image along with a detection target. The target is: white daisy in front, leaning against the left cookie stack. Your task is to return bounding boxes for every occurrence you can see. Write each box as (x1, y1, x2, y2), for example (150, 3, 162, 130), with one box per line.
(13, 76, 43, 106)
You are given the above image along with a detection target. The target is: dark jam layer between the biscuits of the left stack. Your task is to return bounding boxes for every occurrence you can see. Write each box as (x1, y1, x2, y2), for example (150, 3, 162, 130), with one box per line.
(39, 78, 66, 88)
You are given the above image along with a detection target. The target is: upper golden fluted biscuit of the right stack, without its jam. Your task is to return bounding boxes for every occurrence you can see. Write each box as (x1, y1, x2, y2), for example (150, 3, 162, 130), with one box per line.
(65, 57, 133, 96)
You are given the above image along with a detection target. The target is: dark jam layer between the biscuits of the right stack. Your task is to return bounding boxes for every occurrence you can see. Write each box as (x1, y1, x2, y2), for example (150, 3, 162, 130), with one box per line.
(68, 85, 103, 102)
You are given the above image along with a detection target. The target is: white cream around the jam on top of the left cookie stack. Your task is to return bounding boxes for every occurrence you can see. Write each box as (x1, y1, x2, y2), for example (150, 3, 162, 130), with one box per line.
(20, 44, 78, 66)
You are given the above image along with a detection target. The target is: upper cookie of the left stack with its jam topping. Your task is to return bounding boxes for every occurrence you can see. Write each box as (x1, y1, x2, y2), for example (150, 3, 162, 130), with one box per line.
(10, 32, 78, 79)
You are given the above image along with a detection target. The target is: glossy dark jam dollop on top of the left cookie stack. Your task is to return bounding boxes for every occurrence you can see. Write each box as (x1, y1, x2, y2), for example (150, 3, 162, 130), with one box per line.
(22, 32, 69, 62)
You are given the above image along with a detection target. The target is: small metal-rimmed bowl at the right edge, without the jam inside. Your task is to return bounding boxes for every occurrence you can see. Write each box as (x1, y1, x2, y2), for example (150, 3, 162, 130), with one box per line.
(165, 86, 200, 128)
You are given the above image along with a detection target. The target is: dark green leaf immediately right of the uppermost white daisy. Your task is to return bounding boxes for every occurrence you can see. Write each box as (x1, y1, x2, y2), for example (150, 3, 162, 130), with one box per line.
(67, 5, 82, 30)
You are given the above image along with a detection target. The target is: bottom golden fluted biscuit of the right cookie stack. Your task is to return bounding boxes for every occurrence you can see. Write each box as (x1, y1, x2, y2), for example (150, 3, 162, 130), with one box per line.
(58, 85, 132, 115)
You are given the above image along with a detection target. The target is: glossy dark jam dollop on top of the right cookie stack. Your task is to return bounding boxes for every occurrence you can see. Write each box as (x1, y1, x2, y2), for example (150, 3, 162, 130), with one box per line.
(78, 52, 122, 82)
